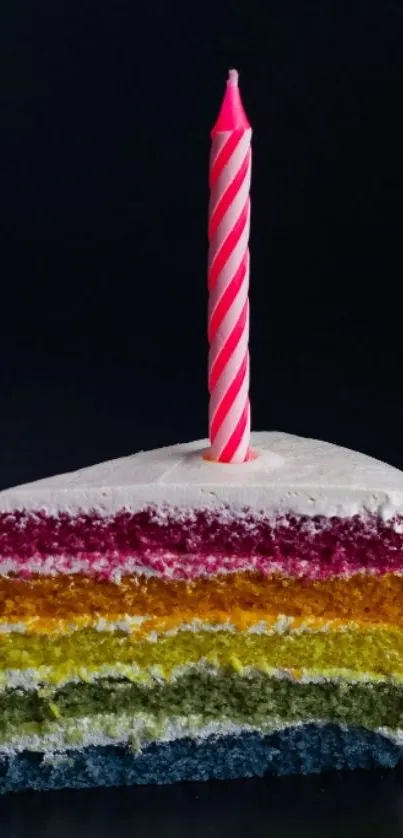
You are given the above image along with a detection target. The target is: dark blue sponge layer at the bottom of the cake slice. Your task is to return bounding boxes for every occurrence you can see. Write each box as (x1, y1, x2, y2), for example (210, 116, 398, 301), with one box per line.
(0, 724, 403, 793)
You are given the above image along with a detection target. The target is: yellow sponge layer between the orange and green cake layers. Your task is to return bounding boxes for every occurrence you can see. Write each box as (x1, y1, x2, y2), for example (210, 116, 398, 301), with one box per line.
(0, 629, 403, 679)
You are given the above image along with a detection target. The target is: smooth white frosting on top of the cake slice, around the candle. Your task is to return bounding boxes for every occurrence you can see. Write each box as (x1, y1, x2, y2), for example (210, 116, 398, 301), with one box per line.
(0, 432, 403, 520)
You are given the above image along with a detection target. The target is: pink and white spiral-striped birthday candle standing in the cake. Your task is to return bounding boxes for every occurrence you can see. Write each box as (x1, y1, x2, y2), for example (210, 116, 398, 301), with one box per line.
(208, 70, 252, 463)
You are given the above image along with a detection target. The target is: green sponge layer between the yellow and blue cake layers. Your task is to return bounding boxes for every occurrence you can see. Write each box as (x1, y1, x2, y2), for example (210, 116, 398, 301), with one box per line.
(0, 669, 403, 742)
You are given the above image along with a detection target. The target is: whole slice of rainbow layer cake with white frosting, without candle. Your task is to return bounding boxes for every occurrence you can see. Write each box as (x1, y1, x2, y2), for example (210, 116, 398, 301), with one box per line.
(0, 433, 403, 792)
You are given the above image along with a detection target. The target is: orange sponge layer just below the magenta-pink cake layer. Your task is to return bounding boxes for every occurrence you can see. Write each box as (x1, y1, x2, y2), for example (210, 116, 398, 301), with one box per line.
(0, 572, 403, 632)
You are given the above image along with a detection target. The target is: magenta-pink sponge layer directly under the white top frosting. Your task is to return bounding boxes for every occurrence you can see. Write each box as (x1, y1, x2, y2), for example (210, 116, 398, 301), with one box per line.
(0, 508, 403, 578)
